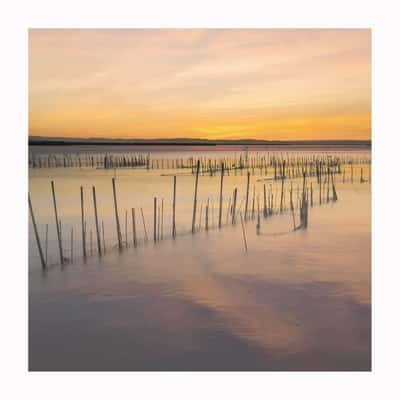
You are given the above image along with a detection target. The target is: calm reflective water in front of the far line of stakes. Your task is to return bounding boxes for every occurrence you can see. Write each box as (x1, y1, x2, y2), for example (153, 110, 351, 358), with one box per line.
(29, 148, 371, 370)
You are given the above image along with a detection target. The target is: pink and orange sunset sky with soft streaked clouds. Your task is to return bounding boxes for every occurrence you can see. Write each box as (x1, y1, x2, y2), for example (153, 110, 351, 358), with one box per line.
(29, 29, 371, 140)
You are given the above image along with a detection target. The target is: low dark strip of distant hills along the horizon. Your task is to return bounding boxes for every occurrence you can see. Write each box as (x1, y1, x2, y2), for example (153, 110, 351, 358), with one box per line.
(29, 136, 371, 147)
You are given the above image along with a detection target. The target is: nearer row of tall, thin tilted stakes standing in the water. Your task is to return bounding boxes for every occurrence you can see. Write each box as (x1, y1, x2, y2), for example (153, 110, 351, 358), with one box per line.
(28, 160, 366, 269)
